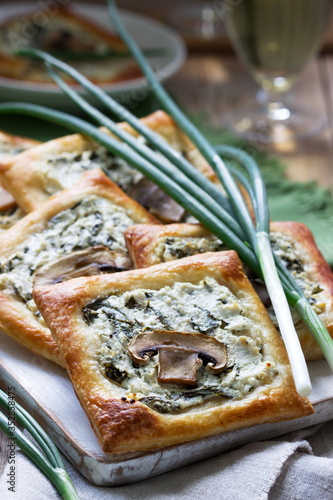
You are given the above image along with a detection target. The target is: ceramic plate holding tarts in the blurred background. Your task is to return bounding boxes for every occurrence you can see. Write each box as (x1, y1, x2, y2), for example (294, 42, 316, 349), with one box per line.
(0, 2, 186, 107)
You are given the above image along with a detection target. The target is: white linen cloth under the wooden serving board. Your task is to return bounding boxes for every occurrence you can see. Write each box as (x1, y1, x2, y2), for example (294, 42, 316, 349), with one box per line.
(0, 420, 333, 500)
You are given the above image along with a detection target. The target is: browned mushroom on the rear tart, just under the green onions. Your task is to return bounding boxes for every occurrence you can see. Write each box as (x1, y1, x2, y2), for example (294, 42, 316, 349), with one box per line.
(127, 178, 185, 223)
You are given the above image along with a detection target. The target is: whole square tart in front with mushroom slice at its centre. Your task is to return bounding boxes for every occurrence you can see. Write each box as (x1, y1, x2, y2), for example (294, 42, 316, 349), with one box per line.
(34, 251, 313, 454)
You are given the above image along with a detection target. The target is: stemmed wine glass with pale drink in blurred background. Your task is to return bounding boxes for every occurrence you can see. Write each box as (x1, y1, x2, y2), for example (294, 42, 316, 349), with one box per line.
(220, 0, 333, 143)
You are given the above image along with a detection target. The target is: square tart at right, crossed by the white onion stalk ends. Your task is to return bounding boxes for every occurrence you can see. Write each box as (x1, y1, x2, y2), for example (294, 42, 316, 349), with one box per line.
(125, 222, 333, 360)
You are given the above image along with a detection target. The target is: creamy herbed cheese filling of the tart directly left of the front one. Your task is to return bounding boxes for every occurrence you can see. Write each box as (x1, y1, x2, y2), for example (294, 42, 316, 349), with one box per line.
(0, 196, 134, 322)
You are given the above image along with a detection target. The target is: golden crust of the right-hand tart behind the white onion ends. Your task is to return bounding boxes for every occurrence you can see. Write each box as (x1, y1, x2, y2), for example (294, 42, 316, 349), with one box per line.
(125, 222, 333, 360)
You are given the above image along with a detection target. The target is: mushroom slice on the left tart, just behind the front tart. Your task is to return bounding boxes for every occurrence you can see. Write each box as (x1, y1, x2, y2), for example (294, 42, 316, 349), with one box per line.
(33, 246, 132, 287)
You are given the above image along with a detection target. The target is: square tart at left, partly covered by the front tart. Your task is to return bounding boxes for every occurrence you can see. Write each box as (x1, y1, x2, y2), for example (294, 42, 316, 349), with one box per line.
(0, 170, 157, 364)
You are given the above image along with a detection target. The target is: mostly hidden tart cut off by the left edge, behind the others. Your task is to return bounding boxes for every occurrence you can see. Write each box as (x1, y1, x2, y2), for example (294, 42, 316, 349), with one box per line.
(0, 130, 40, 232)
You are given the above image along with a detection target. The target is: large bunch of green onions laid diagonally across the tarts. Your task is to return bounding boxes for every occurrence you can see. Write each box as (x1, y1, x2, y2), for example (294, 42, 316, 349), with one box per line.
(0, 0, 333, 396)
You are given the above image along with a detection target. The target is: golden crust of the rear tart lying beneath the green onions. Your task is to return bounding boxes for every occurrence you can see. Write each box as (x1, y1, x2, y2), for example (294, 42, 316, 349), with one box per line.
(0, 111, 217, 212)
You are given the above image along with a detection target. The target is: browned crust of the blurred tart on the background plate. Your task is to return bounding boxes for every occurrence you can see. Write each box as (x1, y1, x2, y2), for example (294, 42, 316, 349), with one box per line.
(0, 6, 142, 86)
